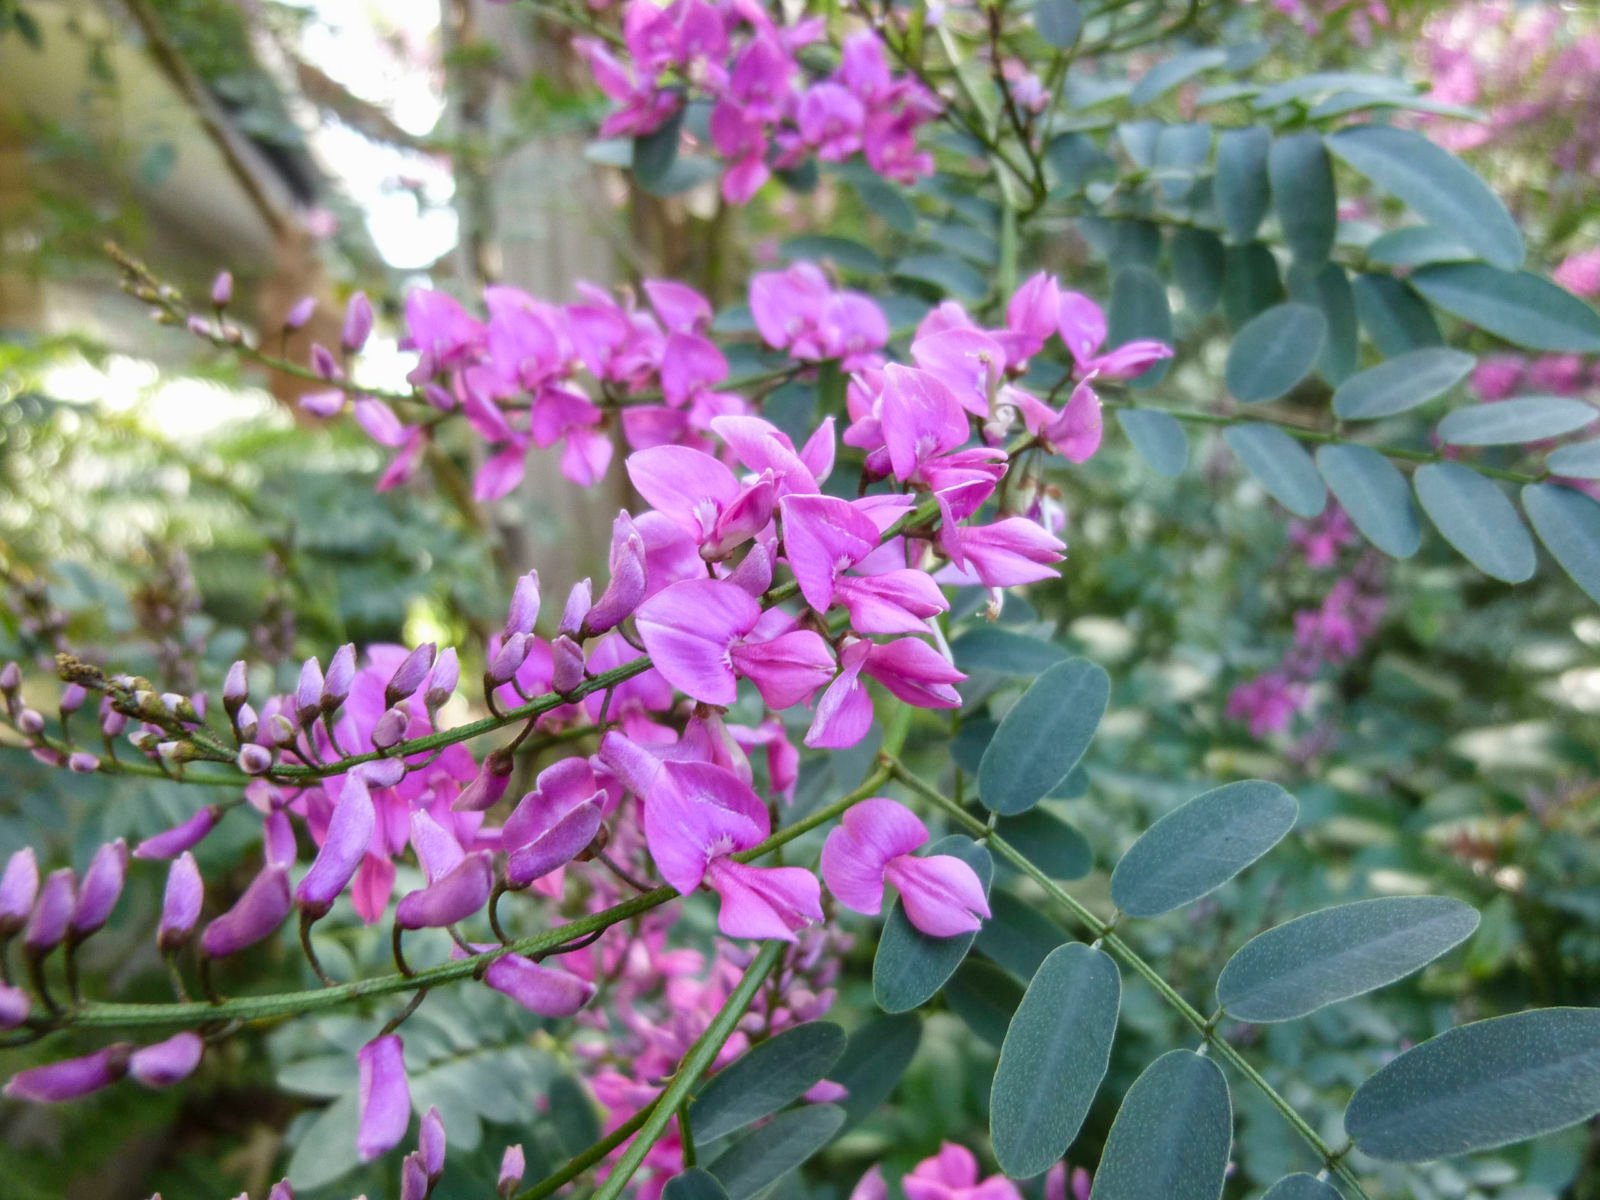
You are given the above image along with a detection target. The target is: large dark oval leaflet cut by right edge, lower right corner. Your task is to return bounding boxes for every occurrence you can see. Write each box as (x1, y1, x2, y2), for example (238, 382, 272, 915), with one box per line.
(1344, 1008, 1600, 1163)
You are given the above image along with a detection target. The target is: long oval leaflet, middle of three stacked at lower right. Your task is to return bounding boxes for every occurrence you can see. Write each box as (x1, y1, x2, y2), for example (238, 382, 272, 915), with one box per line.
(1216, 896, 1478, 1024)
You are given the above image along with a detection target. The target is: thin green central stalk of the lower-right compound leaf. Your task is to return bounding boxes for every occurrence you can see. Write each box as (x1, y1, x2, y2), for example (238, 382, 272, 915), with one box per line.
(886, 758, 1371, 1200)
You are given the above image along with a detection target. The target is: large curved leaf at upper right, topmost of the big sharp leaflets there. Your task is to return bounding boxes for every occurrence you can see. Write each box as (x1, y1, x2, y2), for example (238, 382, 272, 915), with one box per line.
(1328, 125, 1525, 270)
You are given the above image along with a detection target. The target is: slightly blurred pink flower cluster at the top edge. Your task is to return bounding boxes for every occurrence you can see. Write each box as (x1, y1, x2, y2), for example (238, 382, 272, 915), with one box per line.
(576, 0, 939, 205)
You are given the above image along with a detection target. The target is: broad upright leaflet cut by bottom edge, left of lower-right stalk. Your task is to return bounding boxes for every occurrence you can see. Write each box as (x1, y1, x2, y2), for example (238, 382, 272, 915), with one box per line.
(1090, 1050, 1234, 1200)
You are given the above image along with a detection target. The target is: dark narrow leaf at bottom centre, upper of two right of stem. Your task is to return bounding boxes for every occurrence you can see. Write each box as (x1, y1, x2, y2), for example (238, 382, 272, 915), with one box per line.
(690, 1021, 845, 1141)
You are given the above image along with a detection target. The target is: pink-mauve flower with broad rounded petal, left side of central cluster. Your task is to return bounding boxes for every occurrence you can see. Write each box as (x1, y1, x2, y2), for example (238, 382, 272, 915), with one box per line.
(637, 579, 834, 709)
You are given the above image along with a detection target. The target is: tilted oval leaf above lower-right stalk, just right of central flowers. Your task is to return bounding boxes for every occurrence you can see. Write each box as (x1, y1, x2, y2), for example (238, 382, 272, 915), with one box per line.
(978, 658, 1110, 816)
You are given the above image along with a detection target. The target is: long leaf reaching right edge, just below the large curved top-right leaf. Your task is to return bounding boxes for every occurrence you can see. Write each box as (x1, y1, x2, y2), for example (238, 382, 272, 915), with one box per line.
(1411, 262, 1600, 354)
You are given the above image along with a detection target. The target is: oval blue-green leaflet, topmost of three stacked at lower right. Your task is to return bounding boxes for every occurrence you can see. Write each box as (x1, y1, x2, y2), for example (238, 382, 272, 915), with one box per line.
(1110, 779, 1299, 917)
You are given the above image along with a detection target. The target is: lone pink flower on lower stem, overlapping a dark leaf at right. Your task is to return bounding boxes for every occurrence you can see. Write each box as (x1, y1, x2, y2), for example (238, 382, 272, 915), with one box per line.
(822, 798, 989, 938)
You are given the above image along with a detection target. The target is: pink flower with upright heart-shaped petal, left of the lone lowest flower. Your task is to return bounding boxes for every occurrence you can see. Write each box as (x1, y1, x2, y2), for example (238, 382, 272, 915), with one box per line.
(645, 762, 822, 941)
